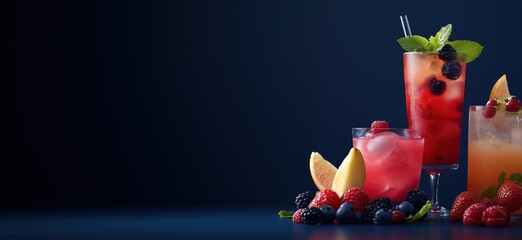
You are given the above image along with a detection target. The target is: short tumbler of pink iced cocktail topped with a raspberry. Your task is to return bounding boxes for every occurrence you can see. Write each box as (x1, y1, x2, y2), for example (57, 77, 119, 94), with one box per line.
(352, 128, 424, 202)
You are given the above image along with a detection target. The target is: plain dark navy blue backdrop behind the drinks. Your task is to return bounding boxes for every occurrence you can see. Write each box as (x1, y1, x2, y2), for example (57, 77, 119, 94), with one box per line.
(0, 0, 522, 210)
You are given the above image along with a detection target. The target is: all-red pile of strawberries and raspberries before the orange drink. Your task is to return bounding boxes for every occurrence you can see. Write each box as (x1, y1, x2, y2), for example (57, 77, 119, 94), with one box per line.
(450, 182, 522, 227)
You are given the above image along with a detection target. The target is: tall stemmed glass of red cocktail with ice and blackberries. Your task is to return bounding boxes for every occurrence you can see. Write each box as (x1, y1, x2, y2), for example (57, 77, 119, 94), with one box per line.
(401, 15, 466, 216)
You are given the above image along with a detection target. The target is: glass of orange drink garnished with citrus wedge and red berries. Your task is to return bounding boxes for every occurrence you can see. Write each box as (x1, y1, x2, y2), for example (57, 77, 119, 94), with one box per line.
(468, 76, 522, 214)
